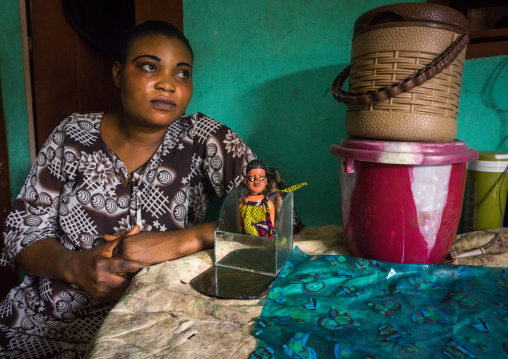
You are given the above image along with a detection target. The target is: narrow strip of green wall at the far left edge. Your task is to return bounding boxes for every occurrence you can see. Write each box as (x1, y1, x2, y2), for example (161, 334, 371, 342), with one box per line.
(0, 0, 31, 201)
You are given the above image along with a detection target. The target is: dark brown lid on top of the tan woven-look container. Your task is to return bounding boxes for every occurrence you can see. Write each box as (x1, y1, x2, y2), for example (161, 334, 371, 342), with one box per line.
(353, 3, 468, 37)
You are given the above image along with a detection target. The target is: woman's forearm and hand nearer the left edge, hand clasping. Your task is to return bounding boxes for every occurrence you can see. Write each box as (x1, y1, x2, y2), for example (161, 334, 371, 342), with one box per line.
(16, 233, 143, 301)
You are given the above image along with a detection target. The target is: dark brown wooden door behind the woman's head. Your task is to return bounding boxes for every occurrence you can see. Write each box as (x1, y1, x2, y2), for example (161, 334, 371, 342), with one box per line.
(30, 0, 183, 149)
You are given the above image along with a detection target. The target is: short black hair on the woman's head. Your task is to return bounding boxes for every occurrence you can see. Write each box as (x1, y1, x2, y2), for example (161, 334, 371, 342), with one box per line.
(116, 20, 194, 65)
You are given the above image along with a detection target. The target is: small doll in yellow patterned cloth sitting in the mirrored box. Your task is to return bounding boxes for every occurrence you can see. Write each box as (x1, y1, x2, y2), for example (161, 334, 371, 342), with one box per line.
(238, 159, 307, 238)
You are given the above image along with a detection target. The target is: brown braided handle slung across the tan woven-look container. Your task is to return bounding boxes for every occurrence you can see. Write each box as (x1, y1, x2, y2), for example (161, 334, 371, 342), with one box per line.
(332, 34, 469, 105)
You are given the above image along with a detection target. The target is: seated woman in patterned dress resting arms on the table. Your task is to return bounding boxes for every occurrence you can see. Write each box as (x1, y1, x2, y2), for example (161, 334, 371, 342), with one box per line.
(0, 21, 255, 358)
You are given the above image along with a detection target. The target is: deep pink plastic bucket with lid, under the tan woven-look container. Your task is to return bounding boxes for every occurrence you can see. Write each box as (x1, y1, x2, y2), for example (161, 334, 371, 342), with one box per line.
(331, 139, 478, 264)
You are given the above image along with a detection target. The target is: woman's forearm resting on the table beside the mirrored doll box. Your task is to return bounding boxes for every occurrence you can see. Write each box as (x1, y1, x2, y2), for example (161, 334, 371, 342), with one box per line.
(109, 222, 217, 265)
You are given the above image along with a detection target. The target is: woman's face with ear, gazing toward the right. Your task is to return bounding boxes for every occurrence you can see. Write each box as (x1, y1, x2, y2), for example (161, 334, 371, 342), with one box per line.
(113, 35, 193, 128)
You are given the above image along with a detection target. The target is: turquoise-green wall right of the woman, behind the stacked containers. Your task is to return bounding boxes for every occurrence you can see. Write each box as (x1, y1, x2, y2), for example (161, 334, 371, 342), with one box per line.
(183, 0, 508, 225)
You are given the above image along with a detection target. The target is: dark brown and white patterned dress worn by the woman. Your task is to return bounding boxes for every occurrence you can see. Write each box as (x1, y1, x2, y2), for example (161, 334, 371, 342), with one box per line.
(0, 113, 254, 358)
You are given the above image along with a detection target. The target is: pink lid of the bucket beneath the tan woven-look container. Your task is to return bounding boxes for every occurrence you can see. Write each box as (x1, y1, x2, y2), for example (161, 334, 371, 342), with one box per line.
(330, 138, 478, 165)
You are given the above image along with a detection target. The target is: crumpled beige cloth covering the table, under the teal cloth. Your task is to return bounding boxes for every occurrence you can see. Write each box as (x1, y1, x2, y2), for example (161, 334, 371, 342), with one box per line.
(84, 226, 508, 359)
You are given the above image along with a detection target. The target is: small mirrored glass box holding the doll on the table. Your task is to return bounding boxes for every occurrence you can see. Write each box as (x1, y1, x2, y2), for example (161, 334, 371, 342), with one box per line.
(191, 186, 293, 299)
